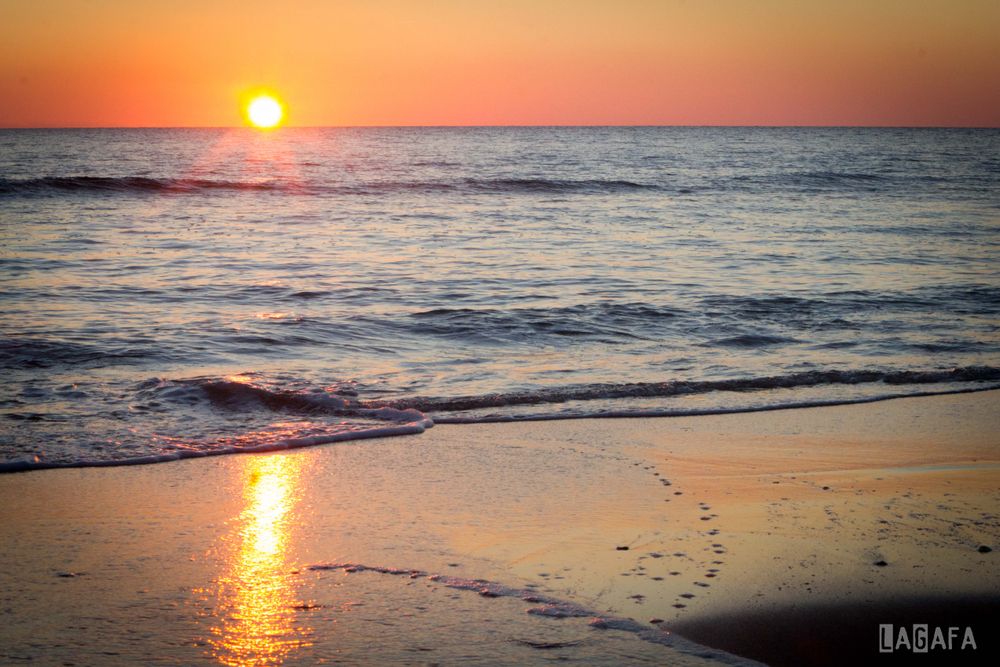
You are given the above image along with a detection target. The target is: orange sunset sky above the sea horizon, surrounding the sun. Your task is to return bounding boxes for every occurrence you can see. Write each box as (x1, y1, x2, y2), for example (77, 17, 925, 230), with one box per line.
(0, 0, 1000, 127)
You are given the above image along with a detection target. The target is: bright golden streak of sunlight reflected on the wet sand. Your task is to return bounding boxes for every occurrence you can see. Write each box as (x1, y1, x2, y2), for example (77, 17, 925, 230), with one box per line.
(209, 456, 310, 666)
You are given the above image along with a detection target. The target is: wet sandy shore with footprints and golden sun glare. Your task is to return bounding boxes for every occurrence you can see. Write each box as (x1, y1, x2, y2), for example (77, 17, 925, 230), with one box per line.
(0, 392, 1000, 664)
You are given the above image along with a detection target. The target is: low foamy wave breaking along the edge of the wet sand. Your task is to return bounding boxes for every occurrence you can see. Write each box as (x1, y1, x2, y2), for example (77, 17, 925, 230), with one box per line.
(0, 366, 1000, 473)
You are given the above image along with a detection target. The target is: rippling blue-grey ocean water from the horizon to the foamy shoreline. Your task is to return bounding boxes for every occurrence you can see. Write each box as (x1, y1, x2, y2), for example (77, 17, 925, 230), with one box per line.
(0, 128, 1000, 470)
